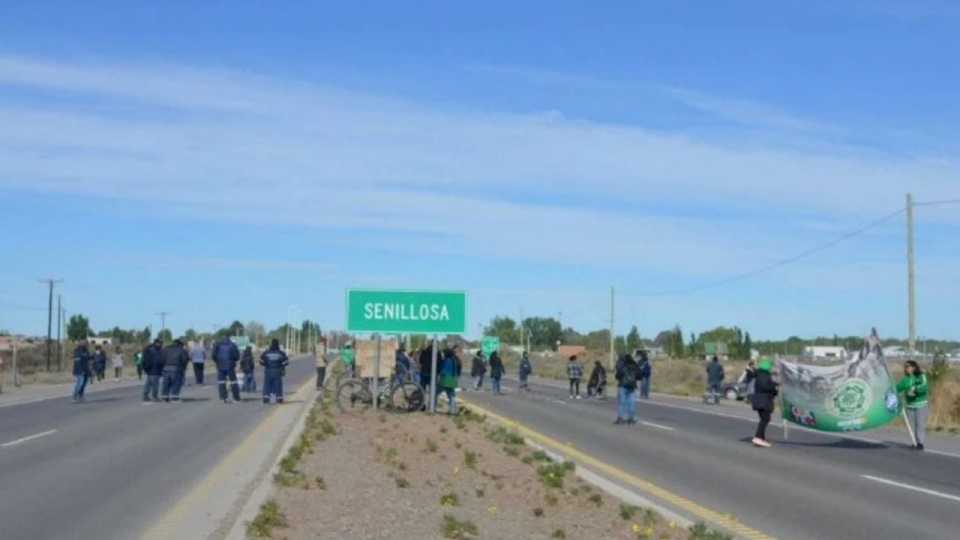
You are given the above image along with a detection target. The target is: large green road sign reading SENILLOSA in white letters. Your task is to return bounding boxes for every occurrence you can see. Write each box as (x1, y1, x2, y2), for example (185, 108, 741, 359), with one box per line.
(347, 289, 467, 334)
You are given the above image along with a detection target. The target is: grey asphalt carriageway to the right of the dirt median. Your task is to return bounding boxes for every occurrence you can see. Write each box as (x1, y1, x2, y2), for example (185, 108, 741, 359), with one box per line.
(465, 378, 960, 540)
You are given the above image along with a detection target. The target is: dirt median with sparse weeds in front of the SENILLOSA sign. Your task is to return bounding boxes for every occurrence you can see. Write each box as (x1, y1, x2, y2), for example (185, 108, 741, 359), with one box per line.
(251, 405, 724, 540)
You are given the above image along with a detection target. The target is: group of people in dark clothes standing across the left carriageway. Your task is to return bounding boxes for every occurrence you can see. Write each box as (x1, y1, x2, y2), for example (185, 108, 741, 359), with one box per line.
(73, 338, 289, 403)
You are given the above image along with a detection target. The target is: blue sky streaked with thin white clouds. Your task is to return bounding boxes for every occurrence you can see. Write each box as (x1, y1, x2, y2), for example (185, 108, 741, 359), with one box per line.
(0, 1, 960, 338)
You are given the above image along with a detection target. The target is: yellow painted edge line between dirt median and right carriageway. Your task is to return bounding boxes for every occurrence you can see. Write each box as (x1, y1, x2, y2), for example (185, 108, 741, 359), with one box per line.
(462, 400, 774, 540)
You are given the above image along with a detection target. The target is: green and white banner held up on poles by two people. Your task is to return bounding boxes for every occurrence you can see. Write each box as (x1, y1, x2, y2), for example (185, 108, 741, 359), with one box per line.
(779, 330, 901, 431)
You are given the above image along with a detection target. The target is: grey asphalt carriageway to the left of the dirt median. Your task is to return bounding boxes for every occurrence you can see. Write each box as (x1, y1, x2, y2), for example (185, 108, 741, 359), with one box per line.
(0, 359, 313, 540)
